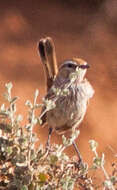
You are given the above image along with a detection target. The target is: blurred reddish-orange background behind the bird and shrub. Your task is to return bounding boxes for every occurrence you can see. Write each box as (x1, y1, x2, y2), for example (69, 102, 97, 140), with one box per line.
(0, 0, 117, 175)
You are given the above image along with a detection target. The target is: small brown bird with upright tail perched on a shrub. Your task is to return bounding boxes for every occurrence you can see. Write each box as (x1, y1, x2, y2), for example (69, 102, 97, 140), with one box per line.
(39, 38, 94, 161)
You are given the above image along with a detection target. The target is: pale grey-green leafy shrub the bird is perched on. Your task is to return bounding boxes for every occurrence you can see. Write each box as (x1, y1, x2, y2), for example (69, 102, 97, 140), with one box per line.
(0, 83, 117, 190)
